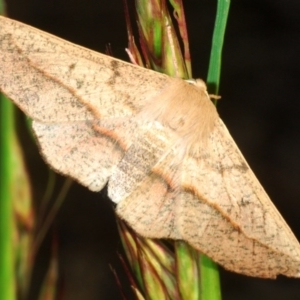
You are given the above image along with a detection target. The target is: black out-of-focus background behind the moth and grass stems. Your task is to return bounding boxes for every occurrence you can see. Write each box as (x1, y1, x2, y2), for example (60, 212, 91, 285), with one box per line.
(2, 0, 300, 300)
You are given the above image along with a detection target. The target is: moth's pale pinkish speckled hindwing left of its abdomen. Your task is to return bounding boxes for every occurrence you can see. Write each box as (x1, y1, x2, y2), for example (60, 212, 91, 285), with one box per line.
(33, 119, 134, 191)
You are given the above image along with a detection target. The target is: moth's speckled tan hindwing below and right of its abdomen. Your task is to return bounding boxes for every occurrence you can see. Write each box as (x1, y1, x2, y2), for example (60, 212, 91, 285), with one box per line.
(116, 172, 181, 239)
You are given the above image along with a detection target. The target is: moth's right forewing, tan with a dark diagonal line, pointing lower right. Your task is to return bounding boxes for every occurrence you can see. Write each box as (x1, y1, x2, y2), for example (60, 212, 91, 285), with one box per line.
(176, 120, 300, 277)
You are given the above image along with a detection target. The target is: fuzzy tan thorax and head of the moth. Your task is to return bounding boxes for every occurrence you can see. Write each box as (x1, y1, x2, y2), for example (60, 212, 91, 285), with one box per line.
(139, 78, 219, 148)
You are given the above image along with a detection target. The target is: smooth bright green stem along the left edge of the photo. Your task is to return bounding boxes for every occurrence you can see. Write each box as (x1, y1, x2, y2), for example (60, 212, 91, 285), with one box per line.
(0, 95, 15, 300)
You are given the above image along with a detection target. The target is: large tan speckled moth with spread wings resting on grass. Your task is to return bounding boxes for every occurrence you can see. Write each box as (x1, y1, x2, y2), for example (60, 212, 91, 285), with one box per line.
(0, 17, 300, 278)
